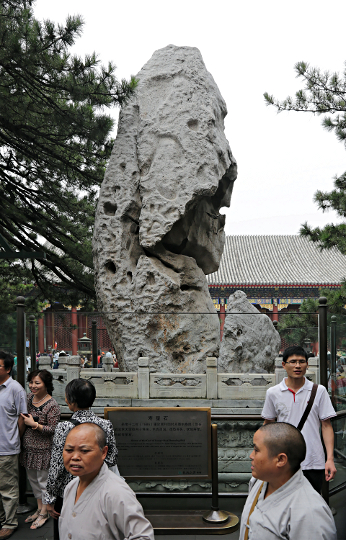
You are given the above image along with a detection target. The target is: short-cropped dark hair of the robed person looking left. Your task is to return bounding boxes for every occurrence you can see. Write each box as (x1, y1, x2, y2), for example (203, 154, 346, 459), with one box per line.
(260, 422, 306, 473)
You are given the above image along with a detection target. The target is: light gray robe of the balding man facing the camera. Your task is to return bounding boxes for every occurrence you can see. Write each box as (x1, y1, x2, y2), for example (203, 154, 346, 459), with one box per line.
(59, 463, 154, 540)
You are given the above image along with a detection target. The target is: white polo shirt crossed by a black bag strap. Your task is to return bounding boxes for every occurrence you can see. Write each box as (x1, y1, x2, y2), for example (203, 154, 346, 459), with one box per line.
(262, 377, 336, 470)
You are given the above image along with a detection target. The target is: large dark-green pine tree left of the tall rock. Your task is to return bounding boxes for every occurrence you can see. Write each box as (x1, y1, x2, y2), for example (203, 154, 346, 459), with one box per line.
(0, 0, 136, 310)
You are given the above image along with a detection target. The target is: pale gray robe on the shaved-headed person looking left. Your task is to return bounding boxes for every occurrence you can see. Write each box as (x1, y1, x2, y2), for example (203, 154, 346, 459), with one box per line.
(239, 469, 336, 540)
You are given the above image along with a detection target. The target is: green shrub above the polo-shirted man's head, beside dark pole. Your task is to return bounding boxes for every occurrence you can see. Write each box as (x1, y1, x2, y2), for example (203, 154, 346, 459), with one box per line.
(278, 298, 318, 347)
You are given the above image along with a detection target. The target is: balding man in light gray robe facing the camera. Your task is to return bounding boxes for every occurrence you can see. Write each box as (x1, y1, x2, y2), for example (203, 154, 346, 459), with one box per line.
(59, 423, 154, 540)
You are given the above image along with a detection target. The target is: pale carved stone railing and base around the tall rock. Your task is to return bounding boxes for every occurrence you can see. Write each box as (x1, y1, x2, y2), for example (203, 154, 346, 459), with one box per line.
(40, 356, 319, 493)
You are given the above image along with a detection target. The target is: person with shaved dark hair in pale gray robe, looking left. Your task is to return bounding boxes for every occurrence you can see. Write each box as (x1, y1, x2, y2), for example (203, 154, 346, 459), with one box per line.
(239, 422, 336, 540)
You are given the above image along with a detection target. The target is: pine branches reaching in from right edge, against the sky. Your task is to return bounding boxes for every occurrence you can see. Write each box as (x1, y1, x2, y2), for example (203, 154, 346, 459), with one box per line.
(264, 62, 346, 312)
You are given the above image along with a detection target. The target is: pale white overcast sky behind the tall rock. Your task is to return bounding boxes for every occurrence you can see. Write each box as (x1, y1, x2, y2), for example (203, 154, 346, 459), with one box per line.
(34, 0, 346, 235)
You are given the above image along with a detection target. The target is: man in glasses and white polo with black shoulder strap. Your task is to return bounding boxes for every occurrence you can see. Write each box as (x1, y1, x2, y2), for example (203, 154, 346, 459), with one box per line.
(262, 346, 336, 493)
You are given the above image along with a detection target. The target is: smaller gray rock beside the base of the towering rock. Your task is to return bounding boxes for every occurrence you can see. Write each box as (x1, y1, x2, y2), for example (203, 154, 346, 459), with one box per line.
(219, 291, 281, 373)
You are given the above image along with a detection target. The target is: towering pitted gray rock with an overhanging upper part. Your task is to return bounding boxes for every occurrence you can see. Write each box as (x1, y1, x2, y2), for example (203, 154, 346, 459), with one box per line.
(93, 45, 236, 373)
